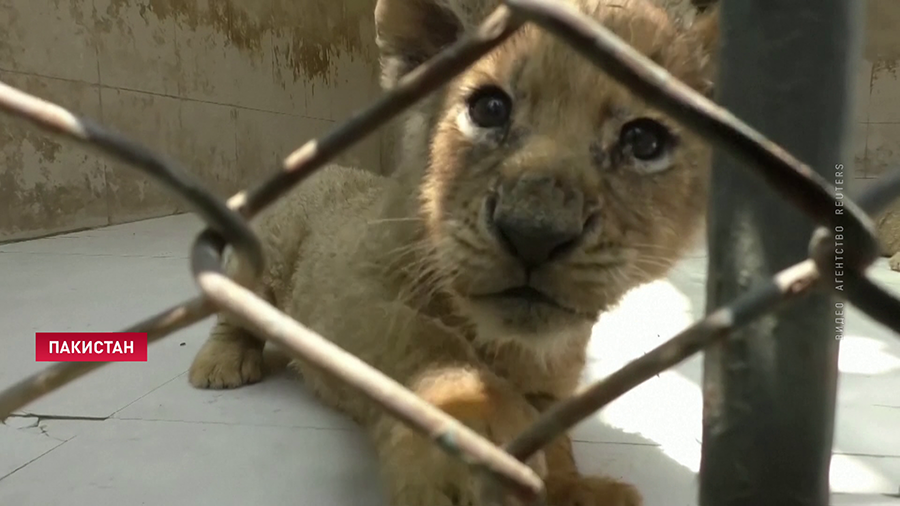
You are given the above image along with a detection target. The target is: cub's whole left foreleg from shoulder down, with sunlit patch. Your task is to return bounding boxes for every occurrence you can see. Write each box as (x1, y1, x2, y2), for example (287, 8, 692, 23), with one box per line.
(294, 302, 546, 506)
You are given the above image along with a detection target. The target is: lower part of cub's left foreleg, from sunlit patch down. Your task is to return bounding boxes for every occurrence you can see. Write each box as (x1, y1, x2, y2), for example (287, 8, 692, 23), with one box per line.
(370, 367, 548, 506)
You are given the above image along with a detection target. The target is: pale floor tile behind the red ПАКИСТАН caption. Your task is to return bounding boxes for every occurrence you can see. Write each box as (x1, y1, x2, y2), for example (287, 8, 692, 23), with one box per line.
(0, 233, 211, 417)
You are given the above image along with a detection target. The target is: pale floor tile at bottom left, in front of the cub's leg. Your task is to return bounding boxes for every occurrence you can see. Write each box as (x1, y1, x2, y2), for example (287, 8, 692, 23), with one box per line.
(0, 420, 383, 506)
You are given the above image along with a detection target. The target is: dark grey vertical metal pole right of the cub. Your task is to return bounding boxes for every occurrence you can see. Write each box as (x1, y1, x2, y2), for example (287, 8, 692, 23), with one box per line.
(699, 0, 864, 506)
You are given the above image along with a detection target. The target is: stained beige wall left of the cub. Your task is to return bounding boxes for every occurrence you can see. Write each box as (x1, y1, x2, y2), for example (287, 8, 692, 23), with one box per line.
(0, 0, 383, 240)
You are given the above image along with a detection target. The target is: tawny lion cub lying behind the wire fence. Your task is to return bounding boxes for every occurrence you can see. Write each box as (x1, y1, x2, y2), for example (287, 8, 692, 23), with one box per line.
(190, 0, 716, 506)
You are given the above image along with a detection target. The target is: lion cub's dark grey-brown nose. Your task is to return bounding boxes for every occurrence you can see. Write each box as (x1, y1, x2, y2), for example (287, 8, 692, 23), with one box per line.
(487, 177, 584, 267)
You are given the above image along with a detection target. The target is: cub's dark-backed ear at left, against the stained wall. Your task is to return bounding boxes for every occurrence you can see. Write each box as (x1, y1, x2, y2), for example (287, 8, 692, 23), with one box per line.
(375, 0, 468, 88)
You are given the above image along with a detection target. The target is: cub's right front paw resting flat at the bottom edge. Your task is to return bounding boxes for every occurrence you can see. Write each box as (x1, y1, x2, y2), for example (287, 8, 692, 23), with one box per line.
(546, 474, 644, 506)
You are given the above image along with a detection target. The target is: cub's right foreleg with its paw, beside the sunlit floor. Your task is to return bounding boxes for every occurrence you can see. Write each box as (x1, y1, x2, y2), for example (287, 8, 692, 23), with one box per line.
(531, 399, 643, 506)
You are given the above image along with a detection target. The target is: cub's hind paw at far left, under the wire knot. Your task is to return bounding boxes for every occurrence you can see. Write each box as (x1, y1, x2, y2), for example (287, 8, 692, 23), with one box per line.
(188, 251, 272, 389)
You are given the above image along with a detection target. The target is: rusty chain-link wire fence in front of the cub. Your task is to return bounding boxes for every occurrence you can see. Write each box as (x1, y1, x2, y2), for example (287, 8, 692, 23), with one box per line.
(0, 0, 900, 504)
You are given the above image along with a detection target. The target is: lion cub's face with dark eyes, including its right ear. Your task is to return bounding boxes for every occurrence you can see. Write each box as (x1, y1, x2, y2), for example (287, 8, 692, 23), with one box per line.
(372, 0, 710, 340)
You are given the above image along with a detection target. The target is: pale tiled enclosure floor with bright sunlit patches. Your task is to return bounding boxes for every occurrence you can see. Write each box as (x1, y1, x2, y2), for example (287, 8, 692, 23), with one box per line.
(0, 216, 900, 506)
